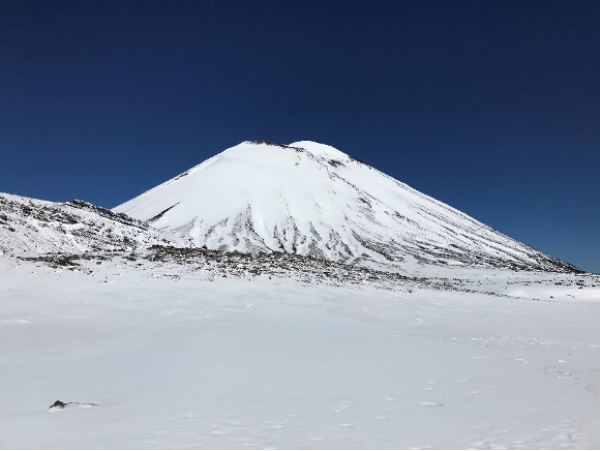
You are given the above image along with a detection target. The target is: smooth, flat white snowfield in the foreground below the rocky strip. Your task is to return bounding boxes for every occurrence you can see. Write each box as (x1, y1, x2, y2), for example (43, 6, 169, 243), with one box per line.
(0, 256, 600, 449)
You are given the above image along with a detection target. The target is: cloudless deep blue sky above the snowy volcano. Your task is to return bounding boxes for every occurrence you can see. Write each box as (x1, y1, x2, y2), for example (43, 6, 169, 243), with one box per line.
(0, 0, 600, 272)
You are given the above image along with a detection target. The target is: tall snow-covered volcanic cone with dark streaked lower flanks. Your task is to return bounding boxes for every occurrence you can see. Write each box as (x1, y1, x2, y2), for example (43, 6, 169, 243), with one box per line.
(114, 141, 577, 271)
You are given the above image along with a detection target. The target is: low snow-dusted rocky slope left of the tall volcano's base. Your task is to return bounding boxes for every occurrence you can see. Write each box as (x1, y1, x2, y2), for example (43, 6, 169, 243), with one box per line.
(0, 193, 189, 255)
